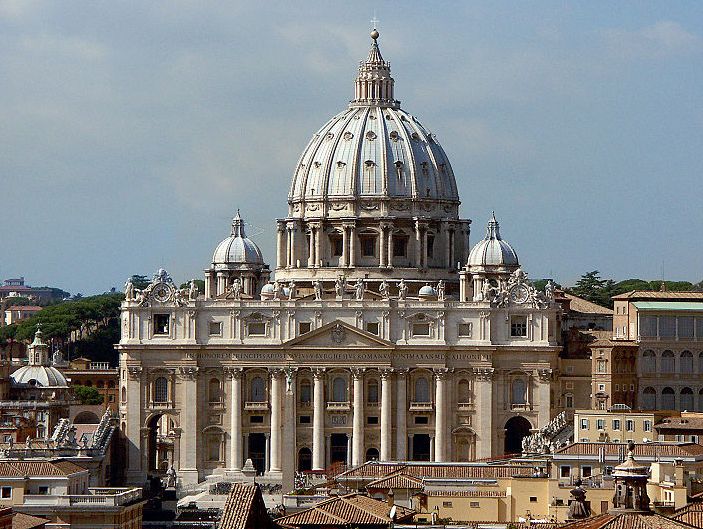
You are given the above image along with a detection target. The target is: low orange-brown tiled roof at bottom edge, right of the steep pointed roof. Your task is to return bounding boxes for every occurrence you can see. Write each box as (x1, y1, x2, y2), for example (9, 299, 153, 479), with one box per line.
(276, 494, 415, 527)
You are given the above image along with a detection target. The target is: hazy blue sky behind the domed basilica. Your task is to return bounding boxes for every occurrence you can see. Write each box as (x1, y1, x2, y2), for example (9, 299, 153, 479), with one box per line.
(0, 0, 703, 294)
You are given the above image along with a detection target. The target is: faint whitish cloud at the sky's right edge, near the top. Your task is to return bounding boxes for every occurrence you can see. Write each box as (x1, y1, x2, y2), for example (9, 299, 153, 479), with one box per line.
(602, 20, 703, 59)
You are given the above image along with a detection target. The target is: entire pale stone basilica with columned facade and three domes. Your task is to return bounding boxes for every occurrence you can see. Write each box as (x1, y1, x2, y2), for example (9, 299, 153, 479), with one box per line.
(118, 30, 560, 483)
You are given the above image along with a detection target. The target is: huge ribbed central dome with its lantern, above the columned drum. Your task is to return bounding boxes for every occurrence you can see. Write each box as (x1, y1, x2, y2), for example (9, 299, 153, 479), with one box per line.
(288, 29, 459, 217)
